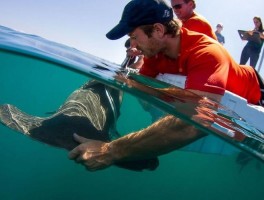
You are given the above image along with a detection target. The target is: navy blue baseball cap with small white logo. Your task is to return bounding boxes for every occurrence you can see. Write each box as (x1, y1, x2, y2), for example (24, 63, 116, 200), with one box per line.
(106, 0, 173, 40)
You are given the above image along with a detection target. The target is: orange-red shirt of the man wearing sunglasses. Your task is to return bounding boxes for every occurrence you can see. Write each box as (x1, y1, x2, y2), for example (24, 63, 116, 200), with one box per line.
(182, 13, 217, 40)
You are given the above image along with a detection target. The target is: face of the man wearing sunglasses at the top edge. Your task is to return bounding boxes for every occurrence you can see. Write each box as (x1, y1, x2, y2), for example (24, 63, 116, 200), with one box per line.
(171, 0, 193, 21)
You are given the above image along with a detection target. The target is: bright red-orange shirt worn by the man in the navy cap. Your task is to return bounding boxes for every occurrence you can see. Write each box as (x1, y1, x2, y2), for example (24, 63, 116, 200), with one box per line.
(140, 28, 260, 104)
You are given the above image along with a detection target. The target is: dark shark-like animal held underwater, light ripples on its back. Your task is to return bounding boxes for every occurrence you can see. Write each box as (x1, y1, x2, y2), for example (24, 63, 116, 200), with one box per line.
(0, 80, 159, 171)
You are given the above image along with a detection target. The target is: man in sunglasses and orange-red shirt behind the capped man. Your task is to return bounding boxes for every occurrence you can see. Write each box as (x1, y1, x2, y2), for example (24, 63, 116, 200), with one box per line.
(171, 0, 217, 40)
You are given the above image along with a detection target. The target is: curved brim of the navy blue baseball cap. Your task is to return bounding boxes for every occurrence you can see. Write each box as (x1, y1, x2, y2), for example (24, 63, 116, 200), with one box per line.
(106, 23, 133, 40)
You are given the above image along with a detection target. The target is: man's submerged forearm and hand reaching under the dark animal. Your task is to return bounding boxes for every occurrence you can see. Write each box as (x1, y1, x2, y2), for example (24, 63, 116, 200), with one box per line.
(69, 115, 205, 171)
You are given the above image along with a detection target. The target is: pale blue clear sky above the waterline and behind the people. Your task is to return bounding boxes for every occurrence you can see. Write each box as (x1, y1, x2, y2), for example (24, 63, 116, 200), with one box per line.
(0, 0, 264, 76)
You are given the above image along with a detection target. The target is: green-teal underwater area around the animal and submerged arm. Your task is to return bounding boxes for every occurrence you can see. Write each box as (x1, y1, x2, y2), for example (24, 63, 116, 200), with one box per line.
(0, 25, 264, 200)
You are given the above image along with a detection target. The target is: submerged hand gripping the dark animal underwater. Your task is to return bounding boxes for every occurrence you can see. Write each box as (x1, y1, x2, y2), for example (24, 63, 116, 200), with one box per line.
(69, 134, 114, 171)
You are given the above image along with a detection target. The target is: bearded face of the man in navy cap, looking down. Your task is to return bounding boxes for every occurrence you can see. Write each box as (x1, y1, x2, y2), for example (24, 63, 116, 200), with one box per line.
(129, 28, 162, 57)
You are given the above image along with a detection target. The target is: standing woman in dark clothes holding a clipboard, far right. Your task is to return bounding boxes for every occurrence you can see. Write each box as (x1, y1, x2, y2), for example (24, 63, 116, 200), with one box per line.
(240, 17, 264, 68)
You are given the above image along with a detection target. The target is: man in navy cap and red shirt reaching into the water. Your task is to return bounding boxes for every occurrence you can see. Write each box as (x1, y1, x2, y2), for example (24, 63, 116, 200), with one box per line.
(69, 0, 260, 171)
